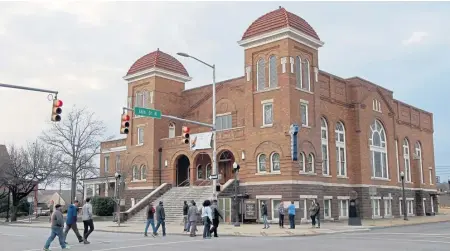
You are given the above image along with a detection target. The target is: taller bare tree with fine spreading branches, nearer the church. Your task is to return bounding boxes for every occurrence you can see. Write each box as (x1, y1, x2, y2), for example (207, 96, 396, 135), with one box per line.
(41, 106, 106, 202)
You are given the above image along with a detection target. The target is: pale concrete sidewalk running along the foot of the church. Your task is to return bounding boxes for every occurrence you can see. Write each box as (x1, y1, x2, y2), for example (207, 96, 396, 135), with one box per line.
(9, 215, 450, 237)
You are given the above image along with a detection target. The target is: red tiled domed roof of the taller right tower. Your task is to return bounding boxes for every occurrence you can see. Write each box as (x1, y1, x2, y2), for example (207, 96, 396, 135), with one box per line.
(242, 6, 320, 40)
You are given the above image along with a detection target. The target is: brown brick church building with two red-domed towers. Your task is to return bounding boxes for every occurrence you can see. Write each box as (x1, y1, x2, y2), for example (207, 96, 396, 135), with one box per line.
(85, 7, 437, 220)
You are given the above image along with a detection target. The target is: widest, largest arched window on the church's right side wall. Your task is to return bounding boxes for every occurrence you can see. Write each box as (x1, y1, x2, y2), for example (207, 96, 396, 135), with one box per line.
(369, 120, 389, 179)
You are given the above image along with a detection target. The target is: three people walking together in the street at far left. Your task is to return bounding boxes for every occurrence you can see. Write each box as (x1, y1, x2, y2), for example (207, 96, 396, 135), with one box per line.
(44, 198, 94, 251)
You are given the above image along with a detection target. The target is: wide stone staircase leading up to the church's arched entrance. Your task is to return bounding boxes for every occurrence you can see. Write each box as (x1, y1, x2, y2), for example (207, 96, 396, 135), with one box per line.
(128, 186, 212, 224)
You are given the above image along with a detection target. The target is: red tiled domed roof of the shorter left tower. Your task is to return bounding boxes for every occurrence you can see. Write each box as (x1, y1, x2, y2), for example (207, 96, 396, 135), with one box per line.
(127, 48, 189, 77)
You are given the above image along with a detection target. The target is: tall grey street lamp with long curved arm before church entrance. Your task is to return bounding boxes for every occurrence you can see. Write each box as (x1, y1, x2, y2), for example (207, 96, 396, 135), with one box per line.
(177, 52, 217, 199)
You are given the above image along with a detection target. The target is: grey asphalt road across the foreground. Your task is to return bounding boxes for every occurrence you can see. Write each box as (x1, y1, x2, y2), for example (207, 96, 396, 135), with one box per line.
(0, 223, 450, 251)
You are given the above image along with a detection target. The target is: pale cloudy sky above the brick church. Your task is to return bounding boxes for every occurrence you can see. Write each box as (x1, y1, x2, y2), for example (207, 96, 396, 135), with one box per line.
(0, 1, 450, 180)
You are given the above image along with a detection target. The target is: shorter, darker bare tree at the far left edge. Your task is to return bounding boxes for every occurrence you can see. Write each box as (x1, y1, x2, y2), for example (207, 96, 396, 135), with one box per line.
(0, 142, 59, 221)
